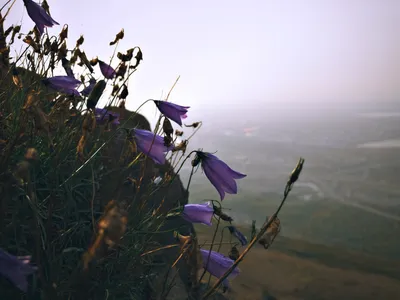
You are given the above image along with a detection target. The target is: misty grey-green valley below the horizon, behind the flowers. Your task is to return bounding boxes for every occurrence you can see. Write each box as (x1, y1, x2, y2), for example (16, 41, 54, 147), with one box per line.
(183, 103, 400, 260)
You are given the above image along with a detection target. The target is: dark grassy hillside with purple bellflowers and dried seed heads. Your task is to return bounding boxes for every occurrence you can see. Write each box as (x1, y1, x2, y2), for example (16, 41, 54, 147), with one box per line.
(0, 0, 304, 299)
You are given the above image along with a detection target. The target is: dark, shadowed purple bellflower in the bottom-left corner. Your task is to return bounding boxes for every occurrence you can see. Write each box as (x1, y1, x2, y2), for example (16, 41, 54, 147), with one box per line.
(0, 249, 37, 292)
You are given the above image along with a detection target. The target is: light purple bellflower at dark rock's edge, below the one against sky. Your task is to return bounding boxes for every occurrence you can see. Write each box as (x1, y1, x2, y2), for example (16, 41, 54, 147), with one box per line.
(133, 128, 173, 165)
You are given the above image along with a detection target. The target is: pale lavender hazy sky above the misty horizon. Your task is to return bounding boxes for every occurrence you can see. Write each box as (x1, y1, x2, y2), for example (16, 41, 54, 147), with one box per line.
(3, 0, 400, 119)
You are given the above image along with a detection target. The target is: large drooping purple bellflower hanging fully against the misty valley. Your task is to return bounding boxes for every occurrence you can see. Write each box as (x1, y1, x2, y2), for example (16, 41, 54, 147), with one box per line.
(195, 151, 247, 201)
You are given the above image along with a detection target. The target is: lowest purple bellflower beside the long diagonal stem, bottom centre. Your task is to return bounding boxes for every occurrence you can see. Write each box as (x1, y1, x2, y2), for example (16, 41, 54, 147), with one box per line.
(200, 249, 240, 287)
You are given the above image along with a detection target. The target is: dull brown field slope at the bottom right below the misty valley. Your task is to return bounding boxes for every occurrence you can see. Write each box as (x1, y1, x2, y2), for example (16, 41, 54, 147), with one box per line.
(197, 226, 400, 300)
